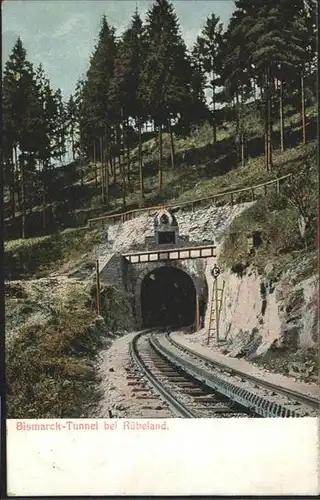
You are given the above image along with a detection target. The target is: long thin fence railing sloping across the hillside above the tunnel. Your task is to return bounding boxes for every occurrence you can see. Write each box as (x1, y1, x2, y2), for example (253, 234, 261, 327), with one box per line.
(88, 174, 292, 226)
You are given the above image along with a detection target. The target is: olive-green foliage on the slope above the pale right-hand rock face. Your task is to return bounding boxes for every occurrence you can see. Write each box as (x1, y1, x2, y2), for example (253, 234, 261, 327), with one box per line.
(220, 148, 318, 271)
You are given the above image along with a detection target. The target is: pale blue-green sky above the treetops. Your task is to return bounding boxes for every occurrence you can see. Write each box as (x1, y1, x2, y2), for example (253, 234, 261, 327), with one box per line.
(2, 0, 234, 99)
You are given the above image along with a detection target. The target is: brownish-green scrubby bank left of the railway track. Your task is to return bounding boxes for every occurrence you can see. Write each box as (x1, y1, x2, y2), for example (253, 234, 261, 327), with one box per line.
(6, 287, 131, 418)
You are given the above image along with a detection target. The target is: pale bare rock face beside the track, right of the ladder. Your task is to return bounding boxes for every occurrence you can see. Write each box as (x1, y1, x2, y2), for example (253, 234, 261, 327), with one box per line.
(216, 264, 318, 366)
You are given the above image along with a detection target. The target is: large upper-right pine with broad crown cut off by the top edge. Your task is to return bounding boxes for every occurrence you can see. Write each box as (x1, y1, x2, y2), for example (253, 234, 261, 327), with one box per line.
(224, 0, 312, 169)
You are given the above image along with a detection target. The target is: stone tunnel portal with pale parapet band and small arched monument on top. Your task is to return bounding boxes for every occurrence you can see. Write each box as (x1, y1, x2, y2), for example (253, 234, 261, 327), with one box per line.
(100, 210, 215, 329)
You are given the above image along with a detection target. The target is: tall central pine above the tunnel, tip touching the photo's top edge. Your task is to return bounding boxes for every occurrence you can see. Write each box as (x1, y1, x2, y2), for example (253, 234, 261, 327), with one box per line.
(139, 0, 191, 192)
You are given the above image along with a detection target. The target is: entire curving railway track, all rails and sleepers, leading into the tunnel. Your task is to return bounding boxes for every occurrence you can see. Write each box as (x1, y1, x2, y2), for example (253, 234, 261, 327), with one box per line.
(131, 330, 319, 418)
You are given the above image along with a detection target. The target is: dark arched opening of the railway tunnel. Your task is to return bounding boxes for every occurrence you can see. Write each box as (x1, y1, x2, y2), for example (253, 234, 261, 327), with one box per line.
(141, 267, 196, 327)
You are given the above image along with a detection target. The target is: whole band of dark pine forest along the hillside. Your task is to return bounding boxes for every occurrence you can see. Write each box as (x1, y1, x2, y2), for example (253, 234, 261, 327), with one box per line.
(2, 0, 317, 237)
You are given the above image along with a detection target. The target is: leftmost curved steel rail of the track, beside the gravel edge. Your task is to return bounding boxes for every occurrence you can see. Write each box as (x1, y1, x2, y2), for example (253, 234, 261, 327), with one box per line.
(130, 330, 197, 418)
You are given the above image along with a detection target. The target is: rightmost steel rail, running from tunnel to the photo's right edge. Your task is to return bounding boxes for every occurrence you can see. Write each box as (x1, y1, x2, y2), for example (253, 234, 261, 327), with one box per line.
(166, 333, 320, 409)
